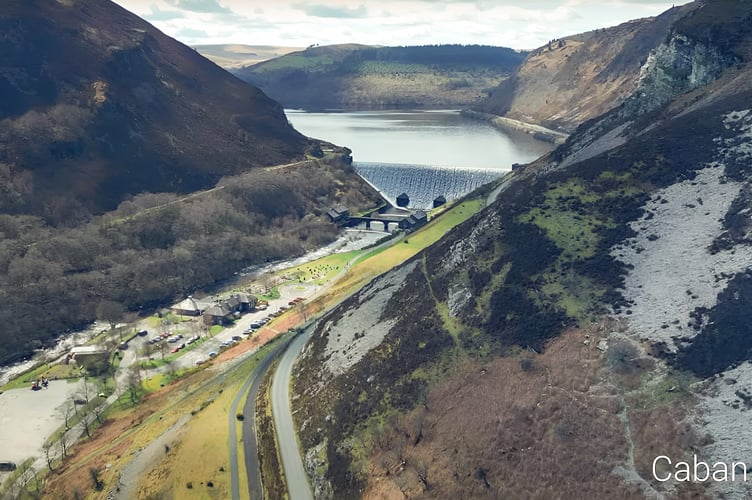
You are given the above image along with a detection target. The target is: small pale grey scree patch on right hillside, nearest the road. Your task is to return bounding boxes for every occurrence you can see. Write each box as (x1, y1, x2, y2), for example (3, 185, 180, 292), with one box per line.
(324, 261, 417, 376)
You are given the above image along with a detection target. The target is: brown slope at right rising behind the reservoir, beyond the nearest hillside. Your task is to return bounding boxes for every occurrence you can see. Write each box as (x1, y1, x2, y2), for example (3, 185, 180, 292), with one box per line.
(472, 6, 692, 132)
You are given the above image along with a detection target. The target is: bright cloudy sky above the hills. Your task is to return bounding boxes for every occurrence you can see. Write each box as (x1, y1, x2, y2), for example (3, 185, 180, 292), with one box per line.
(115, 0, 686, 49)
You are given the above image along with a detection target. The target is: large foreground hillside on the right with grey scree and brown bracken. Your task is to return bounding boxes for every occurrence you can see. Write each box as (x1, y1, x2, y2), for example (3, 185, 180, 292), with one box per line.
(293, 0, 752, 499)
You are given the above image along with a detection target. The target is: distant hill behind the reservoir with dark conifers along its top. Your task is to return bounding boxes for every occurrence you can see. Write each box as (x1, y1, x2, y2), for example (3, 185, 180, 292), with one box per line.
(235, 44, 525, 110)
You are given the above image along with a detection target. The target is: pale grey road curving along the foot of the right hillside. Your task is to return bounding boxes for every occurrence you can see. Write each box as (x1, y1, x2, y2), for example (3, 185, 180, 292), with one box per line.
(272, 327, 313, 500)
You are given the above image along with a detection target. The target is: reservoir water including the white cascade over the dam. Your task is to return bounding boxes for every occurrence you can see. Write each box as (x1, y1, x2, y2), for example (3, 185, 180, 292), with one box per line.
(285, 110, 553, 209)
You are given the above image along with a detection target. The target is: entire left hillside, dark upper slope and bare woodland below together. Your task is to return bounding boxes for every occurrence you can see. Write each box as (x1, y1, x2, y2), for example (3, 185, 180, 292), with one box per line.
(0, 0, 382, 364)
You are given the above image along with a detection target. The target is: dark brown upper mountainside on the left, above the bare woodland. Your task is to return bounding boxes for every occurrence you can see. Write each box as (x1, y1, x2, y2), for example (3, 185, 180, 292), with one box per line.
(0, 0, 308, 223)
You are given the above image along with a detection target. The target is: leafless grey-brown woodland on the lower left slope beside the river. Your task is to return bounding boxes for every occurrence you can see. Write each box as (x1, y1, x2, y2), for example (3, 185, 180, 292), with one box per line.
(0, 156, 381, 364)
